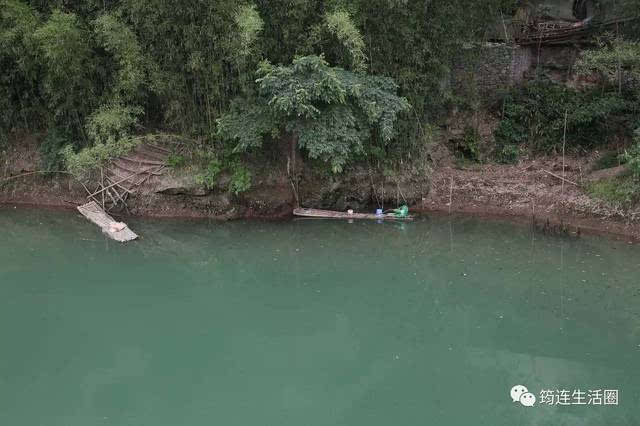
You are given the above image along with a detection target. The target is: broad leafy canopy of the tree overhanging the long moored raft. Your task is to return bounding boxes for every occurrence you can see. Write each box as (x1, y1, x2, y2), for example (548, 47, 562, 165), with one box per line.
(218, 56, 410, 172)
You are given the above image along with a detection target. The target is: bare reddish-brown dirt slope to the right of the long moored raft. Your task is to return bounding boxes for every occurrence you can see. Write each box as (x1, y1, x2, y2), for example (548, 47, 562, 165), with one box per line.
(416, 153, 640, 240)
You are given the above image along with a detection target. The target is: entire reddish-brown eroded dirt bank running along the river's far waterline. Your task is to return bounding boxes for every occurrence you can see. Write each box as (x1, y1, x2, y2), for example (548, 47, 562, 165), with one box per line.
(0, 139, 640, 240)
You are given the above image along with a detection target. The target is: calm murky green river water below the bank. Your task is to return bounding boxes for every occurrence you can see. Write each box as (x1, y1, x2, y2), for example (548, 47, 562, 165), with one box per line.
(0, 207, 640, 426)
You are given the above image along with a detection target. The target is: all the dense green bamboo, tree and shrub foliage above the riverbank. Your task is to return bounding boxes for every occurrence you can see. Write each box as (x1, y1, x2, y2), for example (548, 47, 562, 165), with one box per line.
(0, 0, 640, 185)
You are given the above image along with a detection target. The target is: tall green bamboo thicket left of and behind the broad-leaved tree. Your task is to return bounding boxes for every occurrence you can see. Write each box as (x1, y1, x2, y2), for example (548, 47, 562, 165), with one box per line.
(0, 0, 513, 173)
